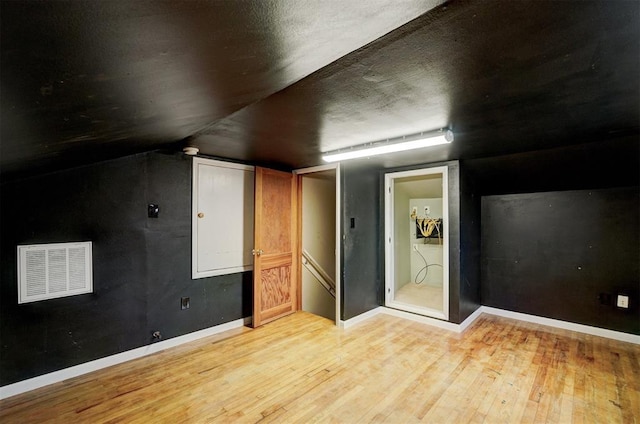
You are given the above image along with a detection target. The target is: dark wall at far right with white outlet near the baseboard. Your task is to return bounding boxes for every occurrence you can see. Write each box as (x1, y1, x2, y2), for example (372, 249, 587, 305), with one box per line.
(482, 187, 640, 334)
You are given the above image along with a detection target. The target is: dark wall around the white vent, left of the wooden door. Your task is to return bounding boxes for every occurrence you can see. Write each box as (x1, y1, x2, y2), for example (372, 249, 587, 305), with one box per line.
(0, 153, 251, 385)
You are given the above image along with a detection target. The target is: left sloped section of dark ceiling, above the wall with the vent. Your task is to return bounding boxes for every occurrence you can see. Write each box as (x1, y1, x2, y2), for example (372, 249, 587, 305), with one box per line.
(0, 0, 441, 176)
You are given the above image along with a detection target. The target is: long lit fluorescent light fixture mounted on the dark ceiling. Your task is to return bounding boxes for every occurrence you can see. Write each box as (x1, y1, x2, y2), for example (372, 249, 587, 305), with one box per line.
(322, 130, 453, 162)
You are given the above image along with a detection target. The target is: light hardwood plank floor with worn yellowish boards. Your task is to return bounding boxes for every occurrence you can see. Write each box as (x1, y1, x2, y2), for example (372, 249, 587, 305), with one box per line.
(0, 313, 640, 424)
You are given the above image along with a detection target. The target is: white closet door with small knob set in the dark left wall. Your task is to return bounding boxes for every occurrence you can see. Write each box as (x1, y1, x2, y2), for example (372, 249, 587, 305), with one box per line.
(192, 158, 254, 278)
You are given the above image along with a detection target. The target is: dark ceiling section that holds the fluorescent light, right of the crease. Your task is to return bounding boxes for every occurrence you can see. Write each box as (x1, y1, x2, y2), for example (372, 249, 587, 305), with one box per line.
(195, 1, 640, 171)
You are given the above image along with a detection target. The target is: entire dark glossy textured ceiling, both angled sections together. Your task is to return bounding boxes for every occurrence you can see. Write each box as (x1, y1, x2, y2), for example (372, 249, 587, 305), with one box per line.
(0, 0, 640, 177)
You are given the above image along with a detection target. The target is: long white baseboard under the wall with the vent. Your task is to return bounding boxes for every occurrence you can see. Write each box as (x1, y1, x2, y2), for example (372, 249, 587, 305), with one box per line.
(0, 317, 251, 399)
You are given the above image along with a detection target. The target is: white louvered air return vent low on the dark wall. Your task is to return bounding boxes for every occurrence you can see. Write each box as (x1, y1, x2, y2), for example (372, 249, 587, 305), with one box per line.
(18, 241, 93, 303)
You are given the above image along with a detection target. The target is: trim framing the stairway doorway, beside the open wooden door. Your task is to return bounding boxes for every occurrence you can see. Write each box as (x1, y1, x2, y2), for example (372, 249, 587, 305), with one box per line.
(293, 163, 342, 325)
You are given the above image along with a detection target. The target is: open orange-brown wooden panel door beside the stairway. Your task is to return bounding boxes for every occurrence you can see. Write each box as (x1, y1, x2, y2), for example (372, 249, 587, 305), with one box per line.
(253, 167, 298, 327)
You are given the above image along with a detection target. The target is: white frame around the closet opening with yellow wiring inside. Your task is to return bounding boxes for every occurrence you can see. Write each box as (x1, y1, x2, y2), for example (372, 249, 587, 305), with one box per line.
(384, 166, 449, 320)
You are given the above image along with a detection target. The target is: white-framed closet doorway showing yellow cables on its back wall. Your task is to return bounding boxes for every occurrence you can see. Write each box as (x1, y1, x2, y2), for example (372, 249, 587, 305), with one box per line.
(385, 166, 449, 320)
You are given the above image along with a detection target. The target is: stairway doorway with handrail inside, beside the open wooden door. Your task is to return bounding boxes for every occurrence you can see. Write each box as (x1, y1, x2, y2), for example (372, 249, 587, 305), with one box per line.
(295, 165, 340, 323)
